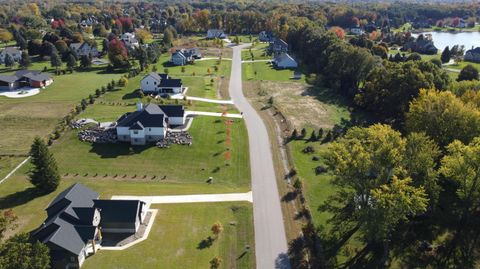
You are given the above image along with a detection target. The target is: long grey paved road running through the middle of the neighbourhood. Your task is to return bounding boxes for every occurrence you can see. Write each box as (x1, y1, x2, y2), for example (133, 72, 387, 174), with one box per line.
(229, 45, 290, 269)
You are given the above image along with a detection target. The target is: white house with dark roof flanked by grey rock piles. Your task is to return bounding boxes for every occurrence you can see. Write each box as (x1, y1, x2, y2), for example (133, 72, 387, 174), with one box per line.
(116, 103, 186, 145)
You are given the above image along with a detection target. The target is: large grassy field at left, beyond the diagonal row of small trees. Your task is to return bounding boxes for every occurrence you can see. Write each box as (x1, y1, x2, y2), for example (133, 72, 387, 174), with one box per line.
(0, 64, 120, 154)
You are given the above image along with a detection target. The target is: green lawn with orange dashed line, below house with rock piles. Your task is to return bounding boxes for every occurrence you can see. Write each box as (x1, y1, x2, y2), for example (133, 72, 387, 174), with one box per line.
(51, 116, 250, 191)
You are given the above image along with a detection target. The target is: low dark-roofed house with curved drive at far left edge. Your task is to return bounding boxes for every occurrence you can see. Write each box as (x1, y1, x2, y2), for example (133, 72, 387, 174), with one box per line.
(0, 70, 53, 91)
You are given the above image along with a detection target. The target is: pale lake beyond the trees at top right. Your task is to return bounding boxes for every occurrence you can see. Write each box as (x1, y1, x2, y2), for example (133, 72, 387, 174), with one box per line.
(413, 32, 480, 51)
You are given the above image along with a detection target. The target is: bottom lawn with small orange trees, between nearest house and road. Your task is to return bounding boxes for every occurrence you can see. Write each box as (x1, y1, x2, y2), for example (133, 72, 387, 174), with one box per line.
(83, 202, 255, 269)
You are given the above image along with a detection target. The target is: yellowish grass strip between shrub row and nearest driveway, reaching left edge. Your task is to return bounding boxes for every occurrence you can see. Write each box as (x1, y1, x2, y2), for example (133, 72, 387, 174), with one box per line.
(0, 171, 248, 236)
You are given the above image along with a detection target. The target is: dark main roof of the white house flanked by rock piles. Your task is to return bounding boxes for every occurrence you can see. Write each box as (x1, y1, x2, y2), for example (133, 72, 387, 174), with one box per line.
(117, 104, 165, 128)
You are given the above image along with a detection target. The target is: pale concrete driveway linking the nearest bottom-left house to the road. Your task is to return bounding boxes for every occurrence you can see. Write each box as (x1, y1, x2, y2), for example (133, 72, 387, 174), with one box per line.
(111, 191, 252, 205)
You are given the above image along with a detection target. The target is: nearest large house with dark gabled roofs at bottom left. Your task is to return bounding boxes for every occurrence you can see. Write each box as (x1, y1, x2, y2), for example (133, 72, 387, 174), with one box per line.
(31, 183, 147, 268)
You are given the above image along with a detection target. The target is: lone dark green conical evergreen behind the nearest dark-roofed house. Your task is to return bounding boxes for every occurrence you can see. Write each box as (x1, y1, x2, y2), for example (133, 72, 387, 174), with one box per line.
(30, 137, 60, 193)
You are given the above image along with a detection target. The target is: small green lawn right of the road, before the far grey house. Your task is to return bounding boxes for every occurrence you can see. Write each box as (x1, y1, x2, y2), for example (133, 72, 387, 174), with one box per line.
(242, 62, 305, 81)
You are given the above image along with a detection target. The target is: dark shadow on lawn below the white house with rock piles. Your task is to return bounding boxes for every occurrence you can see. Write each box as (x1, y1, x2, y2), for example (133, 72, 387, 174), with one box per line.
(90, 143, 150, 159)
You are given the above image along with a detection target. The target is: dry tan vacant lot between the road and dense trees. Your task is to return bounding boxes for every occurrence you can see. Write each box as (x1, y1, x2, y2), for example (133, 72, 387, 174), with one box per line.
(244, 81, 349, 129)
